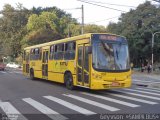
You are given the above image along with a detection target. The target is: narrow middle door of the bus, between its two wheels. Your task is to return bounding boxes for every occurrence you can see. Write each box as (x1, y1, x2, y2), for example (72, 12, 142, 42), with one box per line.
(42, 50, 48, 79)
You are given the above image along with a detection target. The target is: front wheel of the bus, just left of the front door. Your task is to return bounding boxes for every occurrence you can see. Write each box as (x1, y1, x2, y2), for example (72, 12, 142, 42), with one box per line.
(64, 73, 74, 90)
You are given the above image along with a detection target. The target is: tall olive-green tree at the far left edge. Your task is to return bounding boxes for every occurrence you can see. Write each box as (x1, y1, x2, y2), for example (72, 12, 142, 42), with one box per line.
(0, 4, 30, 57)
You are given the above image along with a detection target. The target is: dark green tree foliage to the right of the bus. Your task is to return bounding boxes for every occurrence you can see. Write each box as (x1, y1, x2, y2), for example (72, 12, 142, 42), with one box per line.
(107, 2, 160, 65)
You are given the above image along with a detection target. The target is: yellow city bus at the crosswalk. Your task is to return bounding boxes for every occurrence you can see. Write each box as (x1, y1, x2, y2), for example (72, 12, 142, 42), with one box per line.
(23, 33, 131, 90)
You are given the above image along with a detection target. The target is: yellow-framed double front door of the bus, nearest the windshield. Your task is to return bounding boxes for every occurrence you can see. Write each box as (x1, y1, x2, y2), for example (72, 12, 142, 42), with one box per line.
(77, 44, 90, 87)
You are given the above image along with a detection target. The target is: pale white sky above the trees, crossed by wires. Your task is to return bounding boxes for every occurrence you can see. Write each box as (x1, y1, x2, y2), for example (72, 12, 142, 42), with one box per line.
(0, 0, 151, 26)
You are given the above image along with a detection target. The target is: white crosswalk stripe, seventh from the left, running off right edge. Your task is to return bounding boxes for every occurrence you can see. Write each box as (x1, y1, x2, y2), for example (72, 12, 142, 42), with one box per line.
(112, 91, 160, 100)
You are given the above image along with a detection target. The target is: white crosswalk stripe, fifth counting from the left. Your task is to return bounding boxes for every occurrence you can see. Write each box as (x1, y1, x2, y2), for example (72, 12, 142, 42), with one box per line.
(82, 92, 140, 108)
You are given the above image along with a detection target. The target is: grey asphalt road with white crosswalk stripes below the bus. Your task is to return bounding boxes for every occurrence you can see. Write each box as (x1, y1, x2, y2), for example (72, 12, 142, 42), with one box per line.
(0, 70, 160, 120)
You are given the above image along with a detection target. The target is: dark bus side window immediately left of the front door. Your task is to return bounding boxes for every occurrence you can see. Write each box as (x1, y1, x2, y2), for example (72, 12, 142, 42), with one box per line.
(64, 42, 76, 60)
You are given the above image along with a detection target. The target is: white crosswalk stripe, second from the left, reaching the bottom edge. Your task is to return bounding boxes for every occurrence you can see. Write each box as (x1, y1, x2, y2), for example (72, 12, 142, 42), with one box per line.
(22, 98, 68, 120)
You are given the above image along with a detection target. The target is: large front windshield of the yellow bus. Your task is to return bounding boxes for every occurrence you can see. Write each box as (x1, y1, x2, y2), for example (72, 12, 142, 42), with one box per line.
(93, 40, 130, 71)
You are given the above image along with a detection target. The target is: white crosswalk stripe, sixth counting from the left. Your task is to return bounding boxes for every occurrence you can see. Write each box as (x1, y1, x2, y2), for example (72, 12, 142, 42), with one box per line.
(106, 93, 158, 105)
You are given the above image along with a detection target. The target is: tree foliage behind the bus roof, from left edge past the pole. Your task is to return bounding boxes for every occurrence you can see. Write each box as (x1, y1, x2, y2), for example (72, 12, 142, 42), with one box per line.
(0, 4, 106, 61)
